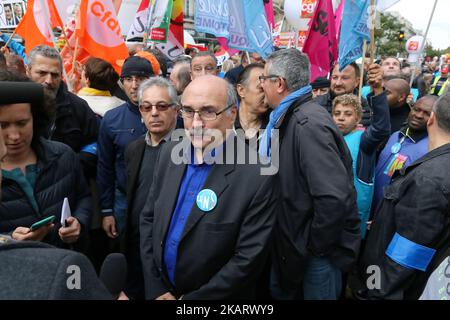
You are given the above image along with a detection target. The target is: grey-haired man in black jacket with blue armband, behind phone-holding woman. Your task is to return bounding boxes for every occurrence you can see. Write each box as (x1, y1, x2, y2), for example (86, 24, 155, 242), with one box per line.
(27, 46, 98, 178)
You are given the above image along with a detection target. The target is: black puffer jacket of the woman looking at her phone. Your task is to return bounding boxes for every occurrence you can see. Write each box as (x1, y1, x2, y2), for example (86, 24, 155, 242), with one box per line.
(0, 139, 92, 247)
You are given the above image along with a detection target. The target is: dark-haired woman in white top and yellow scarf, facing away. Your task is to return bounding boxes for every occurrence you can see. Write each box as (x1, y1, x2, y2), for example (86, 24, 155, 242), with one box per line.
(78, 58, 125, 117)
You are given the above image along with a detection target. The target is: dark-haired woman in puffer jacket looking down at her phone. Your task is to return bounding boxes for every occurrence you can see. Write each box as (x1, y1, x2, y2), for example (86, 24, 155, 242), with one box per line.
(0, 72, 91, 248)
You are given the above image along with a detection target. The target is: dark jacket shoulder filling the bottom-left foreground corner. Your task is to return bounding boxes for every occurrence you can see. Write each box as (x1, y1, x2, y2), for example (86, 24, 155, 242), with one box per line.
(0, 236, 112, 300)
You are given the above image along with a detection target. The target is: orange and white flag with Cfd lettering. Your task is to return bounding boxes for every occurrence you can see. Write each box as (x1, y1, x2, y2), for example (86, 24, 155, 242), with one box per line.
(75, 0, 128, 72)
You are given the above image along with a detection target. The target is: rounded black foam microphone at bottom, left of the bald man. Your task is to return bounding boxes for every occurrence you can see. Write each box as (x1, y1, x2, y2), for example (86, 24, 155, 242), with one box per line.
(100, 253, 127, 300)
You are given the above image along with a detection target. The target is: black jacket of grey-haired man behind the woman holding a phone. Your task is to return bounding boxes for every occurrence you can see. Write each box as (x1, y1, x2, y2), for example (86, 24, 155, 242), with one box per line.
(47, 82, 99, 179)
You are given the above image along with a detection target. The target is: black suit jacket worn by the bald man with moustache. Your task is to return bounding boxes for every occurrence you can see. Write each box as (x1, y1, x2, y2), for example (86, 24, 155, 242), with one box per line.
(140, 137, 276, 299)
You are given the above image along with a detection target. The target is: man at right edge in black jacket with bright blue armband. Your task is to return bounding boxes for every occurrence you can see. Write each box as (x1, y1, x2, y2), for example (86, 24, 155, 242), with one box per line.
(360, 94, 450, 300)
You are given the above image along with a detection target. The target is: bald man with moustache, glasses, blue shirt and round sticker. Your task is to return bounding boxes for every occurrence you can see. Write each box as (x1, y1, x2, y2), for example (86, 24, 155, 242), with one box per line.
(140, 75, 276, 300)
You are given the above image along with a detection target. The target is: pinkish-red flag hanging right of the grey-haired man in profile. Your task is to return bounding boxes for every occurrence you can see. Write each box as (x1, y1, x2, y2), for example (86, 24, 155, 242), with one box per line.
(303, 0, 338, 82)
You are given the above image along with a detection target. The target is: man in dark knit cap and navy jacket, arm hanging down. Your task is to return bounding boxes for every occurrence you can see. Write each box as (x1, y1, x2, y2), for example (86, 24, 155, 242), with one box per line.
(97, 56, 153, 242)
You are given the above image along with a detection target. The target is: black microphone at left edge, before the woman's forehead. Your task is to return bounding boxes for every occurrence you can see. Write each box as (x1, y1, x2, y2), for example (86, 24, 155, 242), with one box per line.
(0, 81, 44, 104)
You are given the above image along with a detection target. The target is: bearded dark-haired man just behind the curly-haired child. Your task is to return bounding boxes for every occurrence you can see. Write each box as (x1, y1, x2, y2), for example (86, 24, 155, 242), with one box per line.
(315, 63, 372, 127)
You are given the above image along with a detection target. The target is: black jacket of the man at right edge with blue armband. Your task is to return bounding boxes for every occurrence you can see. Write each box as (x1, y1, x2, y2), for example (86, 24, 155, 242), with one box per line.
(362, 144, 450, 300)
